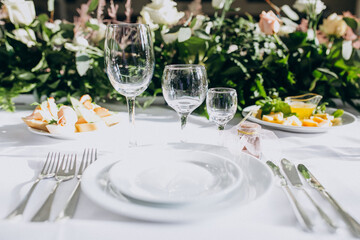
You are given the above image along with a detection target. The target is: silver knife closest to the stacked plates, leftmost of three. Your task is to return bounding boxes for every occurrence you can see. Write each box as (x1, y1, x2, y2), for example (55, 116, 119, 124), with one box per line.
(266, 161, 313, 231)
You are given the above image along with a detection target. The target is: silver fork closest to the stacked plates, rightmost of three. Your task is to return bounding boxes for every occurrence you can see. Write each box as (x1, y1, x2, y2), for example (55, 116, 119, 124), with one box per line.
(55, 149, 97, 221)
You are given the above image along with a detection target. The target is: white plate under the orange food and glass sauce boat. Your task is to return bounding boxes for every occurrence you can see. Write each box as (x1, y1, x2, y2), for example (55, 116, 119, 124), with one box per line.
(242, 105, 356, 133)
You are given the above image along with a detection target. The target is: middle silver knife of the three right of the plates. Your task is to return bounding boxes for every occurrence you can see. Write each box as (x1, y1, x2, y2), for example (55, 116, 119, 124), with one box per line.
(281, 158, 337, 231)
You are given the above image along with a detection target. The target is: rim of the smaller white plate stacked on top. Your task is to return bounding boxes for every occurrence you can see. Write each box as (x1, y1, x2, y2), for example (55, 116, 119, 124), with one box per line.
(109, 149, 244, 205)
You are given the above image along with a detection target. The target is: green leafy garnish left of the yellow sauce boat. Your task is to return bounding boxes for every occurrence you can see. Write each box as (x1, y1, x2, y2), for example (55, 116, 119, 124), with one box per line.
(256, 97, 296, 117)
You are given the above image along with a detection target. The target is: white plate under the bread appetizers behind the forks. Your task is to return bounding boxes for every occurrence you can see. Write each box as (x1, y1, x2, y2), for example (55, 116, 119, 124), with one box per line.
(27, 124, 117, 140)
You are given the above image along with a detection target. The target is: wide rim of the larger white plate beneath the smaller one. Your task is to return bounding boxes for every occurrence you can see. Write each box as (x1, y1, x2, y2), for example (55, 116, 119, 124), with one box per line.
(82, 144, 274, 222)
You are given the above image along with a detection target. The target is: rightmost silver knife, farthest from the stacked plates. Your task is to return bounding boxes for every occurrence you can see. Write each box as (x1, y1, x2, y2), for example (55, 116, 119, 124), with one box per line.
(298, 164, 360, 237)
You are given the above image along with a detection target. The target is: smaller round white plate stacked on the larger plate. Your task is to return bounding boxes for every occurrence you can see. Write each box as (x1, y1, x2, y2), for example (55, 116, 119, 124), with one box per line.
(109, 150, 242, 204)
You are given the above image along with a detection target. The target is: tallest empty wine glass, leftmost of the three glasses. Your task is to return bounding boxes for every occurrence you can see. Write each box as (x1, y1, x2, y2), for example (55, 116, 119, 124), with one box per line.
(105, 23, 155, 146)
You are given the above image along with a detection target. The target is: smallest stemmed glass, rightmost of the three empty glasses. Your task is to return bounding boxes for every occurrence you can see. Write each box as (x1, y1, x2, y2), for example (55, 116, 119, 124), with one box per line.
(206, 88, 237, 143)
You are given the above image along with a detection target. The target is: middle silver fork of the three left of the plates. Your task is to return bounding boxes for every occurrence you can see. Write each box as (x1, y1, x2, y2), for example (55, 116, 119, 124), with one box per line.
(31, 154, 76, 222)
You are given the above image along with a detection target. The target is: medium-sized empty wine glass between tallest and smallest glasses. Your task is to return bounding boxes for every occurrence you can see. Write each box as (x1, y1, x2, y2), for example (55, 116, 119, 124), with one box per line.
(162, 64, 208, 141)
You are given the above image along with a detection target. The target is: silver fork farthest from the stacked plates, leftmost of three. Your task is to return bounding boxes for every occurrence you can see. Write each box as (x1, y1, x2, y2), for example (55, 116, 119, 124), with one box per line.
(6, 152, 60, 219)
